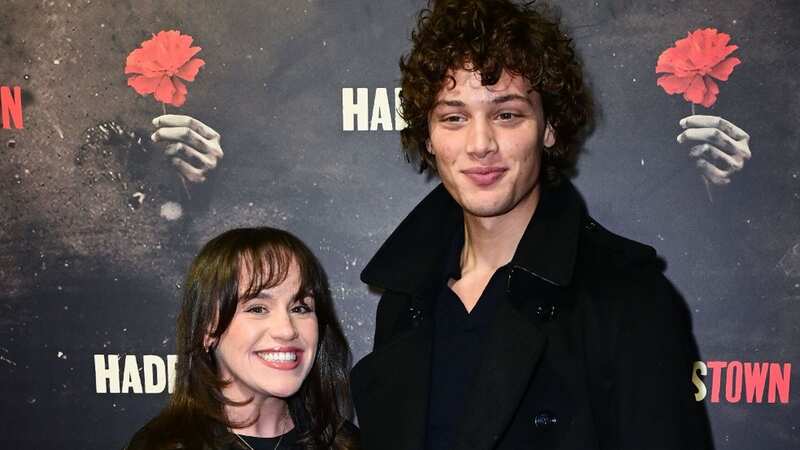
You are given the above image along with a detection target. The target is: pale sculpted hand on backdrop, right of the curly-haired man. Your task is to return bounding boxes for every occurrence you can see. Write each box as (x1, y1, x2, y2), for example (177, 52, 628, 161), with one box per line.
(678, 115, 752, 186)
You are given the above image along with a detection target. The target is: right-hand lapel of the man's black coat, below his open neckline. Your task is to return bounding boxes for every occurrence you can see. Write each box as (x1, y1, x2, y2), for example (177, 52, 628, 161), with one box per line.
(453, 301, 546, 450)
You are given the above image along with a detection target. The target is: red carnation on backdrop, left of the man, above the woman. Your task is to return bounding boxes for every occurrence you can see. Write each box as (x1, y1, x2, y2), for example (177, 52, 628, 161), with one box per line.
(125, 30, 205, 106)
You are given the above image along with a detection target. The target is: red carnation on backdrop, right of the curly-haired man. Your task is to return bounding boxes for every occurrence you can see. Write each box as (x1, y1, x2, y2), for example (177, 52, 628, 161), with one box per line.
(656, 28, 741, 108)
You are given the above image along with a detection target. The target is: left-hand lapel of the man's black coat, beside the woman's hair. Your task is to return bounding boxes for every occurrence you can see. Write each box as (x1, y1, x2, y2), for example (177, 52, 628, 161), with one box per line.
(352, 321, 433, 450)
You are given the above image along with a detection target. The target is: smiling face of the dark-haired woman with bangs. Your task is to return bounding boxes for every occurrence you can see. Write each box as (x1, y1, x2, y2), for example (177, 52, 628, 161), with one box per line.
(214, 260, 319, 400)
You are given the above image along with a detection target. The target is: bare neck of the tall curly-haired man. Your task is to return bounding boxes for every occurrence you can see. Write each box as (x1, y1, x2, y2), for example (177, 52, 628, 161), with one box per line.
(461, 186, 541, 274)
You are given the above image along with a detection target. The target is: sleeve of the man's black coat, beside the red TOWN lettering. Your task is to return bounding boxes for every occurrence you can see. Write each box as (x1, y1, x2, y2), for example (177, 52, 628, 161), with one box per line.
(616, 269, 713, 450)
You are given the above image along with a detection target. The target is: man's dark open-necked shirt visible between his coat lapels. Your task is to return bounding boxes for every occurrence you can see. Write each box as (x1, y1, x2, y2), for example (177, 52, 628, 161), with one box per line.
(425, 231, 507, 450)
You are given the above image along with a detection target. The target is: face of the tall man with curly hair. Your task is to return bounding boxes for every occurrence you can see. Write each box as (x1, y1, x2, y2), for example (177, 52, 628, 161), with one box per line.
(428, 69, 555, 217)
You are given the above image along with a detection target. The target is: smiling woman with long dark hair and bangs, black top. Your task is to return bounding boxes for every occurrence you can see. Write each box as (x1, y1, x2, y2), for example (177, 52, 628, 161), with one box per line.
(128, 227, 357, 450)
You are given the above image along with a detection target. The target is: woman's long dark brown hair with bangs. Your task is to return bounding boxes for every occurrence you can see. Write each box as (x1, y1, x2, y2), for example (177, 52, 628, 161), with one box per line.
(126, 227, 356, 449)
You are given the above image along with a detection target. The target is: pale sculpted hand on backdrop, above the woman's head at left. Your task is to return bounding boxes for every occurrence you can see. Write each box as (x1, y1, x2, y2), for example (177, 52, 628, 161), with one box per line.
(151, 114, 223, 183)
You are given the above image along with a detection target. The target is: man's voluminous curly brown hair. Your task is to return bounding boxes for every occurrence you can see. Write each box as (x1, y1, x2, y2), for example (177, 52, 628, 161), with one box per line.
(400, 0, 593, 185)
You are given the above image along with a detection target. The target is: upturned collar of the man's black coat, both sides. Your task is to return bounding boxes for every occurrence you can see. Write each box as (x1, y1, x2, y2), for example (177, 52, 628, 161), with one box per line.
(361, 181, 586, 295)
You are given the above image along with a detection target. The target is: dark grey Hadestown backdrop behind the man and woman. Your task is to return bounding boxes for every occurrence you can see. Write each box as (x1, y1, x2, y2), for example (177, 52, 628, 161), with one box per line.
(0, 0, 800, 450)
